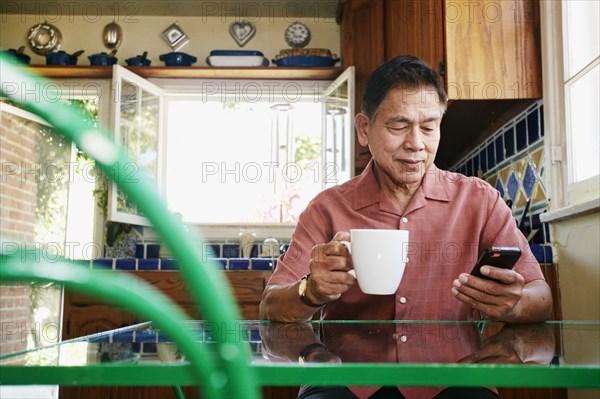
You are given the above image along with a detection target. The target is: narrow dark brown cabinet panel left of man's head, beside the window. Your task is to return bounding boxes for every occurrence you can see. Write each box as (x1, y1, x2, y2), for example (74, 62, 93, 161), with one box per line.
(342, 0, 385, 174)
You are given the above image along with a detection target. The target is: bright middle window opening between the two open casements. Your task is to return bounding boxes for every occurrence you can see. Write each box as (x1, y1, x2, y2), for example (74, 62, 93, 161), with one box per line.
(166, 99, 322, 223)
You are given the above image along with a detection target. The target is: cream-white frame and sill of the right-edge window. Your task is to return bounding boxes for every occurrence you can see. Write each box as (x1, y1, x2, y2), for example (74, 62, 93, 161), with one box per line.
(540, 1, 600, 222)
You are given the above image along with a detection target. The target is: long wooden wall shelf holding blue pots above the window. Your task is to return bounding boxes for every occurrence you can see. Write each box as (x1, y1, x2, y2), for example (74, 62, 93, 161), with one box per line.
(28, 65, 343, 80)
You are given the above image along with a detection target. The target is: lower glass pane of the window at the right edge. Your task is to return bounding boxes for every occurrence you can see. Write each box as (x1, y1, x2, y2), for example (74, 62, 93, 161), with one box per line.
(566, 65, 600, 183)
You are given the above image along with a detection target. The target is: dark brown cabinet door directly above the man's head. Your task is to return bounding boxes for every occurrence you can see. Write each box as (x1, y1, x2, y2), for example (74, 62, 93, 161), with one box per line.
(385, 0, 444, 78)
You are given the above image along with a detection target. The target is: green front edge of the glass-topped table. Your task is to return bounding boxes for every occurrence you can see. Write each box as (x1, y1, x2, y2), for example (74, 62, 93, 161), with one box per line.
(1, 363, 600, 389)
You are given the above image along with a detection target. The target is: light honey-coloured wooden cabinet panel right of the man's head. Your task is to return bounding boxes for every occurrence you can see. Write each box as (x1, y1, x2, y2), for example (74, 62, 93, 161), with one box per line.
(444, 0, 542, 100)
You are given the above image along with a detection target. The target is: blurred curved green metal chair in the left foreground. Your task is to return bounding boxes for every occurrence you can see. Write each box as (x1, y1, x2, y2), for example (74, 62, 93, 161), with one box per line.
(0, 54, 260, 398)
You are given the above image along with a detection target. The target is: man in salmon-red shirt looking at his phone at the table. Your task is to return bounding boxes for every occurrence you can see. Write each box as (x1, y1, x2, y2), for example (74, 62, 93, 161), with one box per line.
(260, 56, 552, 398)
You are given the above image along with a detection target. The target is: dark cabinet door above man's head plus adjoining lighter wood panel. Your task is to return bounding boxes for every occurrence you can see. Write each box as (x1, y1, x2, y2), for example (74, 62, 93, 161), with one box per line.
(384, 0, 542, 100)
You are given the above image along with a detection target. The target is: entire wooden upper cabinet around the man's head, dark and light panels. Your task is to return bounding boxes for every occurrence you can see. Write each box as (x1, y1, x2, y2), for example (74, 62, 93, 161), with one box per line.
(341, 0, 542, 173)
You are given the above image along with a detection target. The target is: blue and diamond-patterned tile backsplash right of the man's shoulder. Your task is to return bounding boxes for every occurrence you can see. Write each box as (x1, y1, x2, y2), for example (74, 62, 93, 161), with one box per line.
(449, 100, 553, 263)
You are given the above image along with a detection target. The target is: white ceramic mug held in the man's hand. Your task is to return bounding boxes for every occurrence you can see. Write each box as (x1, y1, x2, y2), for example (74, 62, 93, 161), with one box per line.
(342, 229, 408, 295)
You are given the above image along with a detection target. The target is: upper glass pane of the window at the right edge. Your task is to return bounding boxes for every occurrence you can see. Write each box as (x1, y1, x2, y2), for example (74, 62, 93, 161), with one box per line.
(563, 0, 600, 80)
